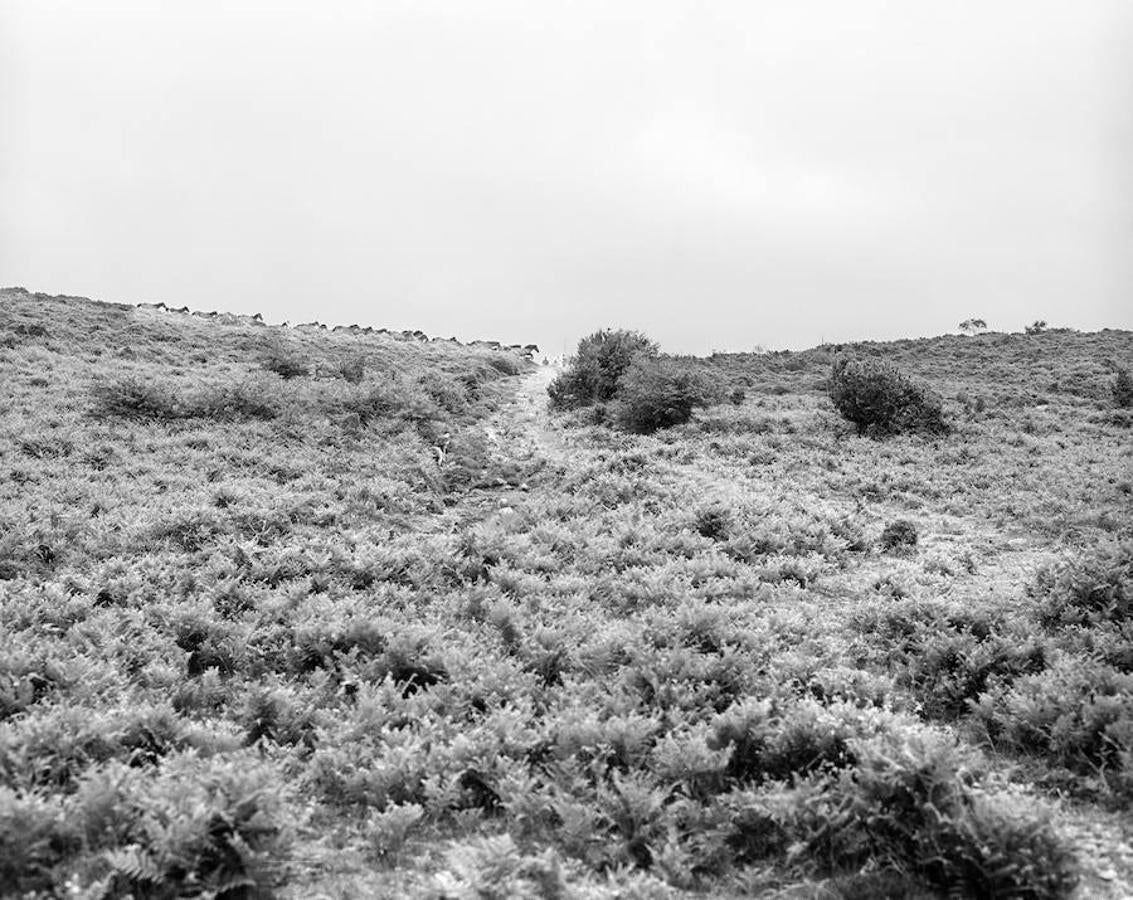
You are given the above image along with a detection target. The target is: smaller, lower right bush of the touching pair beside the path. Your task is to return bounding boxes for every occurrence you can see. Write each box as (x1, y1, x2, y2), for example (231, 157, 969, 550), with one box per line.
(615, 358, 709, 434)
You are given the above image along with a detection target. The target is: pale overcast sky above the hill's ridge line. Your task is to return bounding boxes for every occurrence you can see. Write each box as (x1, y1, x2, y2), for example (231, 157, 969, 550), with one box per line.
(0, 0, 1133, 353)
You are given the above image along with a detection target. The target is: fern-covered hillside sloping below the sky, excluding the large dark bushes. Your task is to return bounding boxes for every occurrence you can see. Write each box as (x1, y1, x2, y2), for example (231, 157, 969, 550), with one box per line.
(0, 290, 1133, 898)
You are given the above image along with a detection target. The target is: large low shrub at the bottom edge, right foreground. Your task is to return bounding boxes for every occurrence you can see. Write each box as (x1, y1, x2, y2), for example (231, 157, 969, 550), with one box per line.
(722, 731, 1077, 900)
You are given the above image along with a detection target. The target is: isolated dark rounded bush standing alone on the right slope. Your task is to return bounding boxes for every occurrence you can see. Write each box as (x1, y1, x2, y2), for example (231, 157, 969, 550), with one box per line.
(828, 357, 947, 435)
